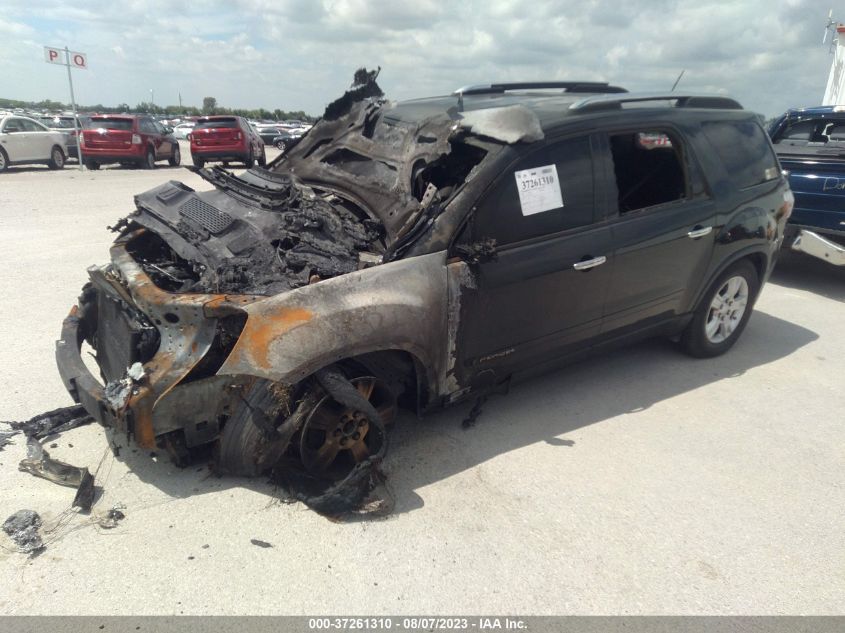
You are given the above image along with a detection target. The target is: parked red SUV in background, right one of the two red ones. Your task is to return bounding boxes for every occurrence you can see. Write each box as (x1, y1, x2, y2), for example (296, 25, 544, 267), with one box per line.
(188, 116, 267, 169)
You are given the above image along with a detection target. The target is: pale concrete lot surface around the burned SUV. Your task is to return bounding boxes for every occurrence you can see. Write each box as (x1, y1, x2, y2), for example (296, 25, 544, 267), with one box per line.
(0, 156, 845, 615)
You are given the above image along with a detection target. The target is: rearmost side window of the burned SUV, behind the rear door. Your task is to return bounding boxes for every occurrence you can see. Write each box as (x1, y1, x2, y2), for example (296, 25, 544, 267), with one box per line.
(701, 121, 780, 189)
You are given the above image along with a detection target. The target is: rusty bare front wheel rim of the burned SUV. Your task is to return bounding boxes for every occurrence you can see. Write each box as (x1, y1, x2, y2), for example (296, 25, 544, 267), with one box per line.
(299, 376, 396, 478)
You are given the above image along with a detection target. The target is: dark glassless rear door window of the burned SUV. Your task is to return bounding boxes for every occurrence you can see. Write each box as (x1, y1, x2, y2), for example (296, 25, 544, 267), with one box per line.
(610, 130, 687, 214)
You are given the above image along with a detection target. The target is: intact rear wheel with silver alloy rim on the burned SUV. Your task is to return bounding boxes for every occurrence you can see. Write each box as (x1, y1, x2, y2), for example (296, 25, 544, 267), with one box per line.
(681, 260, 760, 358)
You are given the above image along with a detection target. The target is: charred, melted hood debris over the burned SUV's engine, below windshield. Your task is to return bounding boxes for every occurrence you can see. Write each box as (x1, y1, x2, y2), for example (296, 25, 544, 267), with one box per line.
(126, 168, 384, 295)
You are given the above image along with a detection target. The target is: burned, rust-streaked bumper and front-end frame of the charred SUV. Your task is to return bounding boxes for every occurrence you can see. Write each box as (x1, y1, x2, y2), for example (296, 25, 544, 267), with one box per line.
(56, 234, 254, 449)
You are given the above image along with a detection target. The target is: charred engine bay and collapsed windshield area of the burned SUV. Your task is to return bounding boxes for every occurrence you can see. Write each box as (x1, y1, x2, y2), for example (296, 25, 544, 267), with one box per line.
(114, 70, 490, 295)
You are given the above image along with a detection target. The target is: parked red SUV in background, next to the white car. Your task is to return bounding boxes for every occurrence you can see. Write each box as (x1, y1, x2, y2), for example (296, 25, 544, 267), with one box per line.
(82, 114, 182, 169)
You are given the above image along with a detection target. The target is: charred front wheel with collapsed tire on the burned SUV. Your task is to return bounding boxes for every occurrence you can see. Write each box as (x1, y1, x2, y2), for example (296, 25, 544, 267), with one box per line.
(216, 376, 397, 479)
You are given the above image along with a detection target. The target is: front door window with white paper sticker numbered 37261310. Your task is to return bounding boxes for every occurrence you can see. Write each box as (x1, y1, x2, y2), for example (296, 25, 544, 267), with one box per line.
(471, 136, 595, 244)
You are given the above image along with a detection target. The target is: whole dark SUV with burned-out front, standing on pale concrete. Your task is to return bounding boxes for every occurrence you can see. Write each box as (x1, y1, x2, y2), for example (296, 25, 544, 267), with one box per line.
(57, 71, 792, 504)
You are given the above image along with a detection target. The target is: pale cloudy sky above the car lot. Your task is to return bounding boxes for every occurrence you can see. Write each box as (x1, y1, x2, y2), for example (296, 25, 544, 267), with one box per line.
(0, 0, 845, 117)
